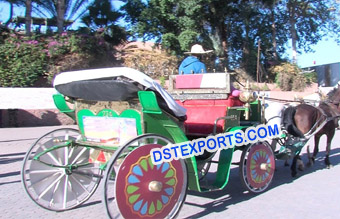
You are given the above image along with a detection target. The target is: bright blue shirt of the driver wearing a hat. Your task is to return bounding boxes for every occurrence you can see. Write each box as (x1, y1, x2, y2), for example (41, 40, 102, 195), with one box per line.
(179, 56, 207, 75)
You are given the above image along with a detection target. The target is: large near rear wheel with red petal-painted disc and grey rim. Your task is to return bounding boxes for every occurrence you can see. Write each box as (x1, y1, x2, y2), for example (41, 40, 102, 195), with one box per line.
(104, 134, 187, 218)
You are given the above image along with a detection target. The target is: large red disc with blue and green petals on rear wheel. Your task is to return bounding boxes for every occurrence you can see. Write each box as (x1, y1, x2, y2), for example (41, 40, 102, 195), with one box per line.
(115, 144, 186, 218)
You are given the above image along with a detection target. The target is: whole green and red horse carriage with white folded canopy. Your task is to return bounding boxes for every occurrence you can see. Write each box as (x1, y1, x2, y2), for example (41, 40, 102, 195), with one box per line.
(22, 67, 340, 218)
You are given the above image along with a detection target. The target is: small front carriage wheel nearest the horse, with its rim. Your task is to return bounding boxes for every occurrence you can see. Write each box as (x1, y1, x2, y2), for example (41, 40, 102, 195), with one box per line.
(239, 142, 275, 193)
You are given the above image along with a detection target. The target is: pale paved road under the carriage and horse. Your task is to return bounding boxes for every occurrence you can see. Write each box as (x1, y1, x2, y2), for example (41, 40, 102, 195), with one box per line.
(0, 127, 340, 219)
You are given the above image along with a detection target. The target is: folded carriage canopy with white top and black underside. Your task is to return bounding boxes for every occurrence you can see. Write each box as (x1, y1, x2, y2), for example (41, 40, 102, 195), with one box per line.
(53, 67, 186, 119)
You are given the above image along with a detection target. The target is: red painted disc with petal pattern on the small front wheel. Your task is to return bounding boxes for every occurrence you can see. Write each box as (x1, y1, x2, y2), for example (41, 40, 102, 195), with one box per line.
(246, 143, 275, 188)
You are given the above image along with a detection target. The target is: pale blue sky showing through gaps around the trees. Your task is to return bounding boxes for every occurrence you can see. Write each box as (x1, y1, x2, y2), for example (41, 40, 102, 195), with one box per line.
(0, 3, 340, 68)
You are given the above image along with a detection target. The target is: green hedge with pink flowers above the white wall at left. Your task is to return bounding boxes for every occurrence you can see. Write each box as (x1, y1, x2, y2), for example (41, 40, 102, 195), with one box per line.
(0, 32, 115, 87)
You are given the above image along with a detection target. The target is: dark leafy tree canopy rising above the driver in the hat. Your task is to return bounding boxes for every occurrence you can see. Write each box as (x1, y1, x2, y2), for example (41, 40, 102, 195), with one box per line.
(122, 0, 340, 75)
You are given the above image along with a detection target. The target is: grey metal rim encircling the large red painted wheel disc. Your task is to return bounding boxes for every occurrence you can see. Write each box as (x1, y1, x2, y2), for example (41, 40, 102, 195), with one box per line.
(103, 134, 187, 218)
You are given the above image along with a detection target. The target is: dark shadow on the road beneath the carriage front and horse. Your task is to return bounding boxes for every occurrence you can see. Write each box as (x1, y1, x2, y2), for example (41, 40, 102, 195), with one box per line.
(185, 148, 340, 218)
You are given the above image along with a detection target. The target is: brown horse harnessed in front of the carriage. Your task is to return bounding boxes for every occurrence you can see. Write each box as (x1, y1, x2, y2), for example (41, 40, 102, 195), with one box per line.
(284, 85, 340, 176)
